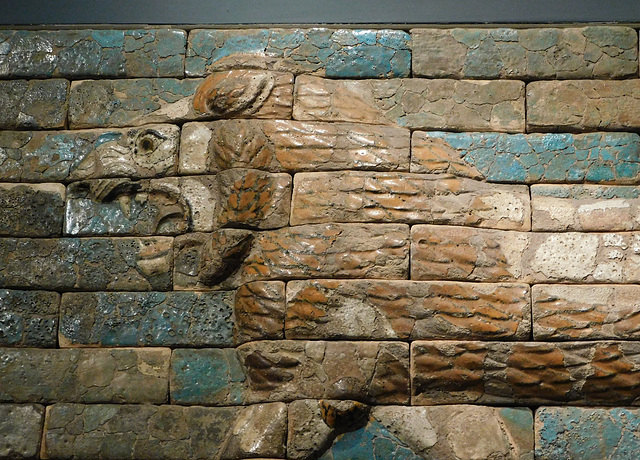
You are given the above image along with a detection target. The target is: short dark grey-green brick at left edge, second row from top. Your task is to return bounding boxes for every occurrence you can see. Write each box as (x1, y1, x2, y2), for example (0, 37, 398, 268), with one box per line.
(0, 79, 69, 129)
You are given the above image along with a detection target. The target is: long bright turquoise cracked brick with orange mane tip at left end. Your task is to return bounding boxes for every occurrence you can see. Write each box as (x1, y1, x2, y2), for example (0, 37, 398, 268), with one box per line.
(411, 131, 640, 184)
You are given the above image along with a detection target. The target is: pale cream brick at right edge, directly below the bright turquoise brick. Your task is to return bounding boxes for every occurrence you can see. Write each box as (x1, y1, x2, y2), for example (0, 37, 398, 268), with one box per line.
(531, 185, 640, 232)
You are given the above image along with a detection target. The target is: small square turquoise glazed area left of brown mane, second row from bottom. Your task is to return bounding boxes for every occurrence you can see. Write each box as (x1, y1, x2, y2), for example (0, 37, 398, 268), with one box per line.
(171, 348, 246, 406)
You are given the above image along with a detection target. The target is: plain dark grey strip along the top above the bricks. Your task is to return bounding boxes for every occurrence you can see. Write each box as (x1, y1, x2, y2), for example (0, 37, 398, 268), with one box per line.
(0, 0, 640, 26)
